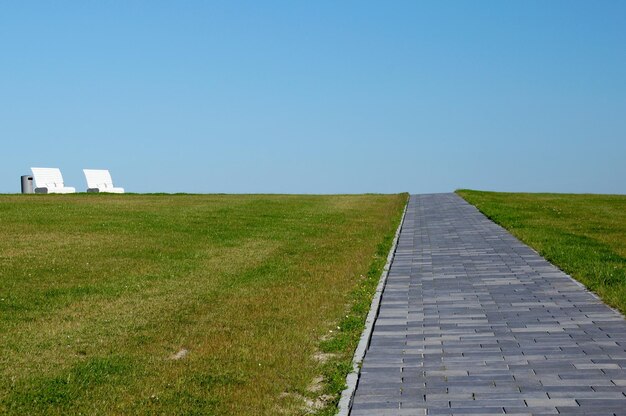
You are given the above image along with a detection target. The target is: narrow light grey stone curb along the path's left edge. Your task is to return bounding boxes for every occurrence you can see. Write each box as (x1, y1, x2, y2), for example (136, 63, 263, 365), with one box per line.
(336, 195, 411, 416)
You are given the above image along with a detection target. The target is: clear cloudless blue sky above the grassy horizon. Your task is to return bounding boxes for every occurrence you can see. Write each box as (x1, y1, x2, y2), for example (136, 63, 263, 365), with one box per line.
(0, 0, 626, 193)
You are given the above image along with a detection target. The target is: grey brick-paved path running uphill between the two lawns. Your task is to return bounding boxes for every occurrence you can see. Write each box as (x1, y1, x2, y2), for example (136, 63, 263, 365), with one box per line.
(351, 194, 626, 416)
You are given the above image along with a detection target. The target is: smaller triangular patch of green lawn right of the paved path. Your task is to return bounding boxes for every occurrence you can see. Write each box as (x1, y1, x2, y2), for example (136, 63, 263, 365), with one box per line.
(457, 190, 626, 313)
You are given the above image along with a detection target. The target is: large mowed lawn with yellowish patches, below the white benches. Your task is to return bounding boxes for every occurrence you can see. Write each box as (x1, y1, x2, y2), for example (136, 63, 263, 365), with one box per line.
(0, 194, 406, 415)
